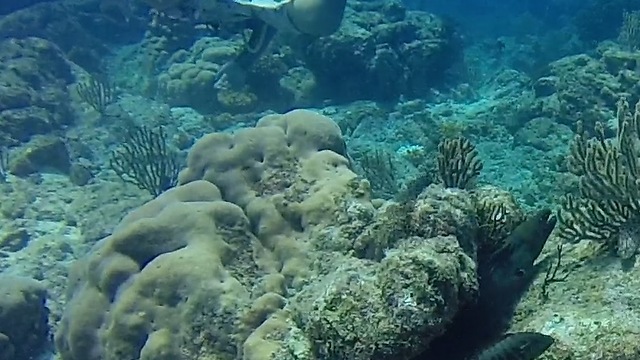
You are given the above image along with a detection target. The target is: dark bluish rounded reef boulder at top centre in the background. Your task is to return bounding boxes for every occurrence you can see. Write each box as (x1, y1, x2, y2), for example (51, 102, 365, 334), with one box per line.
(304, 1, 461, 102)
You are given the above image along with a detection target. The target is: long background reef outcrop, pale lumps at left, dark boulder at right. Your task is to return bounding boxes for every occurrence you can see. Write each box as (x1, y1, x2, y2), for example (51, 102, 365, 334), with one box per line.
(121, 2, 462, 109)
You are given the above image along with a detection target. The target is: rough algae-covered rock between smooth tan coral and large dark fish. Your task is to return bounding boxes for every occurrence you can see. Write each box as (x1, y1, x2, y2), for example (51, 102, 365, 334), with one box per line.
(284, 236, 477, 360)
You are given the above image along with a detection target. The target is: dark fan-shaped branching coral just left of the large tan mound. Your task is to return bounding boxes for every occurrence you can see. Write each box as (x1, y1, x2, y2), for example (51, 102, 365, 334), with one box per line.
(109, 126, 180, 196)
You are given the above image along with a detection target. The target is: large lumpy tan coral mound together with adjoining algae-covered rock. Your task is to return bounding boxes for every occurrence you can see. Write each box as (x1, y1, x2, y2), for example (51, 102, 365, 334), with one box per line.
(55, 110, 477, 360)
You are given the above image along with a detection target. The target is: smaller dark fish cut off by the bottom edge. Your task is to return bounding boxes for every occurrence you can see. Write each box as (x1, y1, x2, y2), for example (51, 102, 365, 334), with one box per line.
(472, 332, 554, 360)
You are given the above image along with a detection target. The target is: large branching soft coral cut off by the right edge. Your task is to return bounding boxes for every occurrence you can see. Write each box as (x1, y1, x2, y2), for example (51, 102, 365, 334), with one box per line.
(558, 99, 640, 259)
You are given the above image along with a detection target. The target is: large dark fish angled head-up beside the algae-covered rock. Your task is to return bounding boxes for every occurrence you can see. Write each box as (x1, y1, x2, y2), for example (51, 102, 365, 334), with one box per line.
(413, 210, 556, 360)
